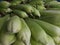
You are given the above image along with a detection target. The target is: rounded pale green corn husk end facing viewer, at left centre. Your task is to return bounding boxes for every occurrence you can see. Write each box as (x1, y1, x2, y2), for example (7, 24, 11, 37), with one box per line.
(7, 16, 22, 33)
